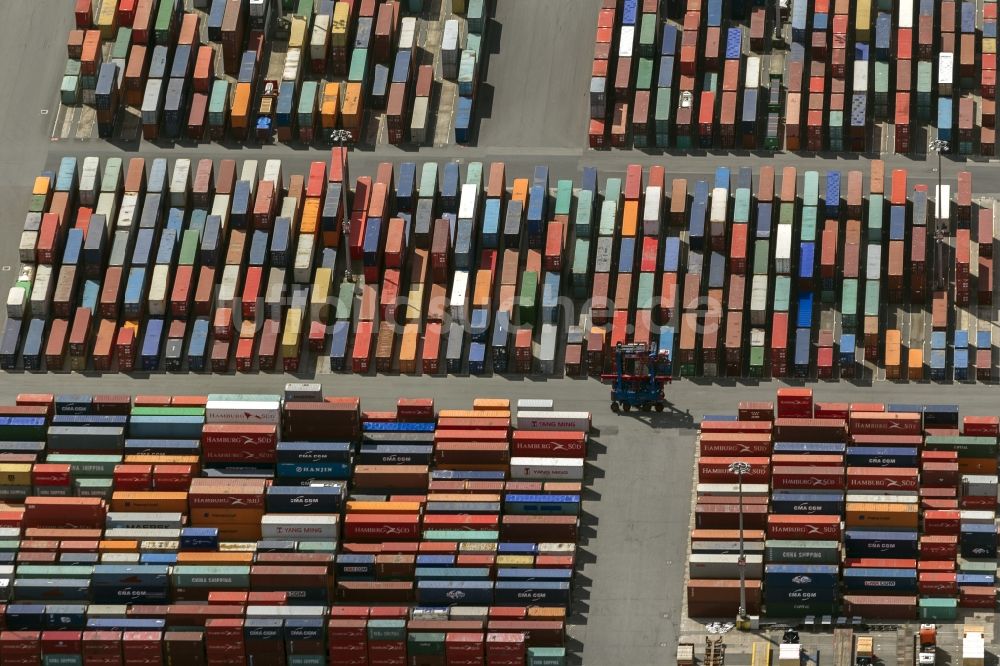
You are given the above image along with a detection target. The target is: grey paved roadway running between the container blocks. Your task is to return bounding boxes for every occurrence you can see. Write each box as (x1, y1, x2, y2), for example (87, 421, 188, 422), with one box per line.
(0, 0, 1000, 665)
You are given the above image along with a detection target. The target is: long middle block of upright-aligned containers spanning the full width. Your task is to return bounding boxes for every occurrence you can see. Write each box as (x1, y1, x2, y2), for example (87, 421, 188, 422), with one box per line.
(0, 156, 994, 381)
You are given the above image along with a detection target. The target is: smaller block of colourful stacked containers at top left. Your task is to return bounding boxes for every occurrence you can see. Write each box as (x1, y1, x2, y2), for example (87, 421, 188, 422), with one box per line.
(61, 0, 485, 143)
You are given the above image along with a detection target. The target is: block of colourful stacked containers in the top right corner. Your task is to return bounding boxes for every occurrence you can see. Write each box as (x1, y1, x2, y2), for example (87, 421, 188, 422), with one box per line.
(589, 0, 997, 156)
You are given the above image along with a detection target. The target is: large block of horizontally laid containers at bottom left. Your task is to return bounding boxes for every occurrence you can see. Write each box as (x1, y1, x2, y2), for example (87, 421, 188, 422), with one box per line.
(0, 384, 590, 666)
